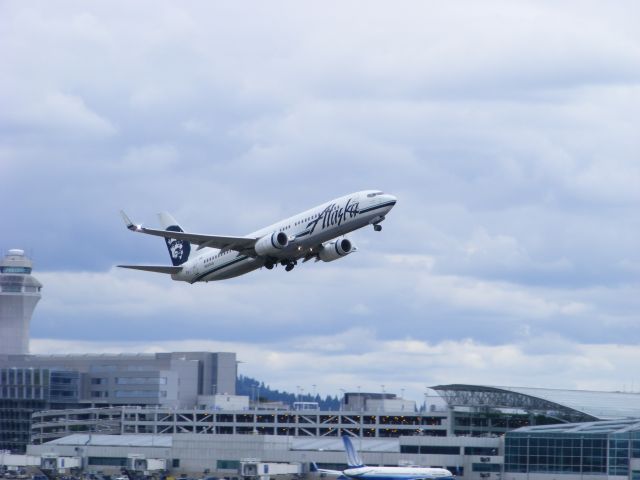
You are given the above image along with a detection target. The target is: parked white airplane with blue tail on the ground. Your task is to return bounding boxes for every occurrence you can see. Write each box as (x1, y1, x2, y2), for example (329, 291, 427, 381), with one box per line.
(311, 435, 455, 480)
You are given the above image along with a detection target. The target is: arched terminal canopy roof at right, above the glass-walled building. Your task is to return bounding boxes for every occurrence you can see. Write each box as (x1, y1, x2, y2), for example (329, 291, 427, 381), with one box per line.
(431, 384, 640, 422)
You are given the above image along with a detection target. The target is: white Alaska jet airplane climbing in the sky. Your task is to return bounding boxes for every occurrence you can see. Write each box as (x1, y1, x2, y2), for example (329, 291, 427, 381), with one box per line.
(118, 190, 396, 284)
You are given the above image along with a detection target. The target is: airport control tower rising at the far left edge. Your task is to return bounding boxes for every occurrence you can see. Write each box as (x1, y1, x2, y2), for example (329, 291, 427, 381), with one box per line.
(0, 249, 42, 355)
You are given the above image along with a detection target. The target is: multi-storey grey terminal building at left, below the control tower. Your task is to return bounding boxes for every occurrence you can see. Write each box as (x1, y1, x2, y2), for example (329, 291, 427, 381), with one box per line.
(0, 352, 237, 452)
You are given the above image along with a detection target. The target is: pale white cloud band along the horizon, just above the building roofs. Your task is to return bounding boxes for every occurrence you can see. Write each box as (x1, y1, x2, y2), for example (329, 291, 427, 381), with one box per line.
(31, 330, 640, 404)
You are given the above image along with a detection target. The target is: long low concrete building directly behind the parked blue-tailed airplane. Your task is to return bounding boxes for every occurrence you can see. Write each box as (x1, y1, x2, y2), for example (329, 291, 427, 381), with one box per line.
(28, 433, 502, 480)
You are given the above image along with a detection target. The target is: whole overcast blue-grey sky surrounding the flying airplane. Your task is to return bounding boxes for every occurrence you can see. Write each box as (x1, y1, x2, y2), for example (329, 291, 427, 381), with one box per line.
(0, 0, 640, 401)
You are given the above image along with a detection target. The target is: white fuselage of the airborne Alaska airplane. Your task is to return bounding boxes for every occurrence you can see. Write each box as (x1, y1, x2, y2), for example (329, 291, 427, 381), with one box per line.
(171, 190, 396, 283)
